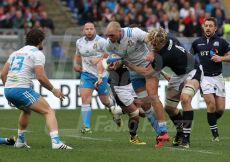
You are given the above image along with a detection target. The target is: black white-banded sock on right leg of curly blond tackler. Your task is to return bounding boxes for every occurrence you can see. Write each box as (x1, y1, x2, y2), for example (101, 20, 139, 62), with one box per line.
(183, 111, 194, 142)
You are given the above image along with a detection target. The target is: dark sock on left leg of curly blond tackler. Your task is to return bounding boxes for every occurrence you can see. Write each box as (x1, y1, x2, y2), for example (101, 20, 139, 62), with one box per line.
(169, 111, 183, 136)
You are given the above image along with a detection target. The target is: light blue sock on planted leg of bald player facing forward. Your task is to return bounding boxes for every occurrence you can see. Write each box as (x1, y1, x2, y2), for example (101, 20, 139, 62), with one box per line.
(81, 104, 91, 128)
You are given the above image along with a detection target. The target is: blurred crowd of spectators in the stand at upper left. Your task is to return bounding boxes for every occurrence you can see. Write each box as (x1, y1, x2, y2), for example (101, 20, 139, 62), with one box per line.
(0, 0, 54, 31)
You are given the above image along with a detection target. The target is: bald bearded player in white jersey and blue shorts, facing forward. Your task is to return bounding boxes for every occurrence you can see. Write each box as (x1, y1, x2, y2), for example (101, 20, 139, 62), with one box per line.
(74, 22, 121, 133)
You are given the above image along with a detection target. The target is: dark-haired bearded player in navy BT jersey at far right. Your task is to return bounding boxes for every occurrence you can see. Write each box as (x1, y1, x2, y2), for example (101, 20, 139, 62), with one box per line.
(191, 17, 230, 142)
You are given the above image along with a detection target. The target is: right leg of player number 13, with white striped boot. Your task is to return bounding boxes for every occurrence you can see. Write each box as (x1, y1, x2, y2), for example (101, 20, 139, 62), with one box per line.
(30, 97, 72, 149)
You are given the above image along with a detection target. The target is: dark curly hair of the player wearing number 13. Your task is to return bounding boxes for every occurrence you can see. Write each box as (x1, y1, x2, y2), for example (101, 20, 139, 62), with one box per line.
(26, 28, 45, 46)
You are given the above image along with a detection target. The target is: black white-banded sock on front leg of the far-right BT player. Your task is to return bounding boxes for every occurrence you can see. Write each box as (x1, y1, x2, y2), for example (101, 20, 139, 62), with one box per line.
(207, 112, 219, 137)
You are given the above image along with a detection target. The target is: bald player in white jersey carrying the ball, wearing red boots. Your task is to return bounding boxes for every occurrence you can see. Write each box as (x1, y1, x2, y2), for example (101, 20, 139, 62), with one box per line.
(106, 21, 169, 147)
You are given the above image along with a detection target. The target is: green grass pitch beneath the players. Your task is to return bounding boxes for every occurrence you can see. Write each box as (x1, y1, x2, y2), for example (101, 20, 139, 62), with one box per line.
(0, 110, 230, 162)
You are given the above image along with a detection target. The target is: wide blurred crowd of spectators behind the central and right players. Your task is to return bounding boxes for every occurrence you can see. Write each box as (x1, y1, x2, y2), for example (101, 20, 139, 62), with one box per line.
(71, 0, 225, 36)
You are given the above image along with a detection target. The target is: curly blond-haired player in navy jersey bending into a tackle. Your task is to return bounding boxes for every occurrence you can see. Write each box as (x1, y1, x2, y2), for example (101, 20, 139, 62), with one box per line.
(126, 28, 202, 148)
